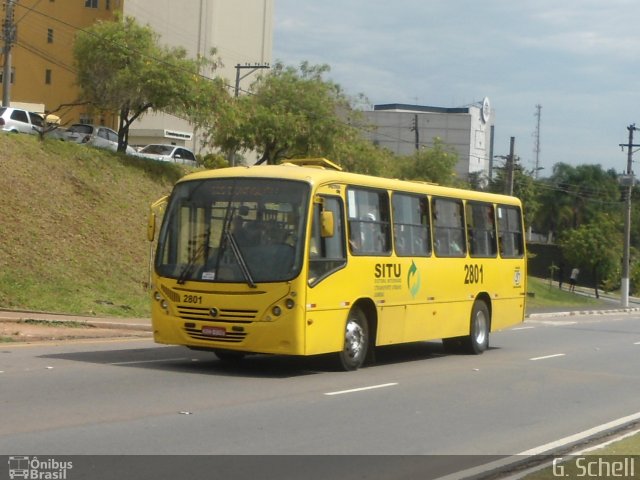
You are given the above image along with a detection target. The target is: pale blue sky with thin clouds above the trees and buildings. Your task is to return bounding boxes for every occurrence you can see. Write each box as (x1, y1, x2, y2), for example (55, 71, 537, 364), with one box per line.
(273, 0, 640, 177)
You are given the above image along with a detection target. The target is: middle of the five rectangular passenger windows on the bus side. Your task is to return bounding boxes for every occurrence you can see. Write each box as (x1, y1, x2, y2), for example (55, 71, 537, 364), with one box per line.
(432, 198, 467, 257)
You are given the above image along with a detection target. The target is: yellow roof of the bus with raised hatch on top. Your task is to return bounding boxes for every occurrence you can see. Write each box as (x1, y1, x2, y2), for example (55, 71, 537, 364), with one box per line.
(179, 159, 520, 205)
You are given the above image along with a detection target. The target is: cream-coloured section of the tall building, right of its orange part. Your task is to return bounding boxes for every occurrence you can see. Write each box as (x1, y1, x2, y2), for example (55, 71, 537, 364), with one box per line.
(122, 0, 274, 152)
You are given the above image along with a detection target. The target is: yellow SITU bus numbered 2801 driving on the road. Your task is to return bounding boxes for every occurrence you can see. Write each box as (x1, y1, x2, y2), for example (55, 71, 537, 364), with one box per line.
(149, 159, 526, 370)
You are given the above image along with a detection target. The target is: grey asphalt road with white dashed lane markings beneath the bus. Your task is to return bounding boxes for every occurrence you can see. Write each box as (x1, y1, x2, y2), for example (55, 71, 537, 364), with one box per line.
(0, 313, 640, 478)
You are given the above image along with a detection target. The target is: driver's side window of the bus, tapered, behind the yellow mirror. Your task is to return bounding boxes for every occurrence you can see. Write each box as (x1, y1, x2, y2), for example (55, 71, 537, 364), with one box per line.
(308, 197, 346, 286)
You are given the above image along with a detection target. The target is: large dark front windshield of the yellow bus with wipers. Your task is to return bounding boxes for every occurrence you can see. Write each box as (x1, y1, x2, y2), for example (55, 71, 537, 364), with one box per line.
(155, 178, 309, 287)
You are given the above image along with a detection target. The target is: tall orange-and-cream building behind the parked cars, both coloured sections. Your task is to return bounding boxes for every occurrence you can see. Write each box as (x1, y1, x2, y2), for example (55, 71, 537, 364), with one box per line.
(2, 0, 274, 150)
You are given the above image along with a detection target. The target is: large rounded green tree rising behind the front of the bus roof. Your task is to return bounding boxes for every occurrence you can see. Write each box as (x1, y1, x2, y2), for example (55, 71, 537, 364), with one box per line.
(208, 62, 364, 164)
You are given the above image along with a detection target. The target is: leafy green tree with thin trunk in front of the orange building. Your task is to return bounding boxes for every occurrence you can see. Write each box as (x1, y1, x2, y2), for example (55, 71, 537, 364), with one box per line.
(73, 17, 223, 152)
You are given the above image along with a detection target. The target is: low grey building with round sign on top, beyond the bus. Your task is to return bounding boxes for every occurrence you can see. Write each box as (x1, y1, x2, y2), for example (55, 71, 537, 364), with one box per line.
(364, 98, 495, 179)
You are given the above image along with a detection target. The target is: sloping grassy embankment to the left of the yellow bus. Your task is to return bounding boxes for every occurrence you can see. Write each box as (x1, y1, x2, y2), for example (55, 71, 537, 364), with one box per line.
(0, 134, 186, 316)
